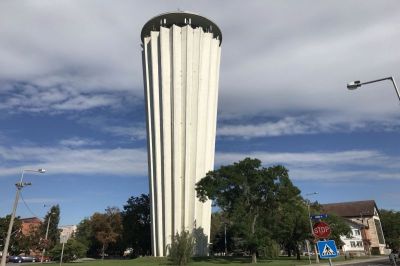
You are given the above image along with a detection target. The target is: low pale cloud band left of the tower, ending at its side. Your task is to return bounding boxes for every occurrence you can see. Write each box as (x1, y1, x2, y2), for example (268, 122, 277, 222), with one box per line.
(0, 146, 147, 176)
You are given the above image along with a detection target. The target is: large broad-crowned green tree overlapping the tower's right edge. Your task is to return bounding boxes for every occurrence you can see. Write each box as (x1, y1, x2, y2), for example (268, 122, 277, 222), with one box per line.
(196, 158, 299, 263)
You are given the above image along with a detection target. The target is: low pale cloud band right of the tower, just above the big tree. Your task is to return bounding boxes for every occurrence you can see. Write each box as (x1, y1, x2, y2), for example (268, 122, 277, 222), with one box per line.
(215, 150, 400, 182)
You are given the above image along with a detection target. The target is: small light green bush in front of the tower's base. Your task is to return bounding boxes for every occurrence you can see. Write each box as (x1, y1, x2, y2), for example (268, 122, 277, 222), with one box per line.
(169, 231, 195, 266)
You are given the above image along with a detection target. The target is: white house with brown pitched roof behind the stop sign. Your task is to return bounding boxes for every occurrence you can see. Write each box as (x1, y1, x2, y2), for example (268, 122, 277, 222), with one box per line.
(322, 200, 388, 255)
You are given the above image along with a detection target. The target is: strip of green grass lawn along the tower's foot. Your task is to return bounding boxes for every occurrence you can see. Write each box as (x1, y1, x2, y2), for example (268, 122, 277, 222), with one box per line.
(59, 257, 376, 266)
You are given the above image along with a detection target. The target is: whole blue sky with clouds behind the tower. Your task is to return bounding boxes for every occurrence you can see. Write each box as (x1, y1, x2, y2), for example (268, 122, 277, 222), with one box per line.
(0, 0, 400, 225)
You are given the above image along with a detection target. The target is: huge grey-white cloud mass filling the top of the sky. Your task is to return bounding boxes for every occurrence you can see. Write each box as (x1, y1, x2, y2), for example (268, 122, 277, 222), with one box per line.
(0, 0, 400, 123)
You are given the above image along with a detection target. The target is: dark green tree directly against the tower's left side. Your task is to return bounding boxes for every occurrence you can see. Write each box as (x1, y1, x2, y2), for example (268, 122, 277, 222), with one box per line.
(122, 194, 151, 256)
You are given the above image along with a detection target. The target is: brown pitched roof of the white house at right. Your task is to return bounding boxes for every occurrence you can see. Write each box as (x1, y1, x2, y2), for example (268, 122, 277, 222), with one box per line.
(322, 200, 378, 218)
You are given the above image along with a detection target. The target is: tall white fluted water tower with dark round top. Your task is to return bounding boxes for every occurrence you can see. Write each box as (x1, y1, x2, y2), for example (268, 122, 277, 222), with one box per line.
(141, 12, 222, 256)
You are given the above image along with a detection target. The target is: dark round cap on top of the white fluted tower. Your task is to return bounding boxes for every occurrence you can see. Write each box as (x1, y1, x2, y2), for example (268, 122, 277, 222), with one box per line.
(141, 11, 222, 45)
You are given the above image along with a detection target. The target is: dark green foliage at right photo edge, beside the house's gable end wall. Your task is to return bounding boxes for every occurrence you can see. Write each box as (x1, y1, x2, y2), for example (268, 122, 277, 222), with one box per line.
(380, 209, 400, 250)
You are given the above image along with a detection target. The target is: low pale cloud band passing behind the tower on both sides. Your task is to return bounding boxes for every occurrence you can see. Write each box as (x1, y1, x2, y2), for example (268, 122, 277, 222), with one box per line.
(0, 142, 400, 182)
